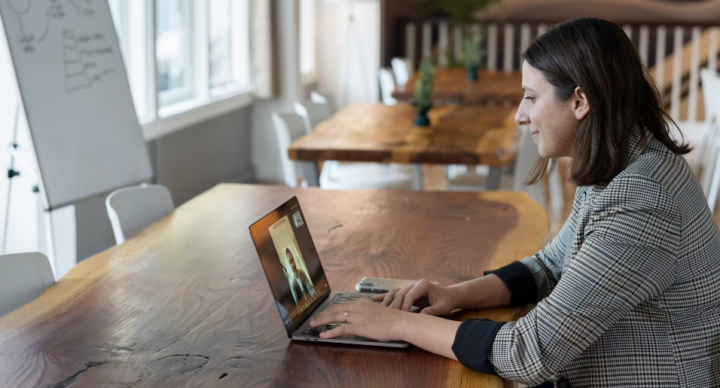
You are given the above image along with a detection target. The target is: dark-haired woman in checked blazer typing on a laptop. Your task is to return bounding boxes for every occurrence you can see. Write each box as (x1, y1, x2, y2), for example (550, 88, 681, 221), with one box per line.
(313, 19, 720, 387)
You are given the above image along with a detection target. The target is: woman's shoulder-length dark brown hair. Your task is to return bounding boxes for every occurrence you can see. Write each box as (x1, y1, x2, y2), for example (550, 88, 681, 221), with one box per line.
(523, 18, 690, 186)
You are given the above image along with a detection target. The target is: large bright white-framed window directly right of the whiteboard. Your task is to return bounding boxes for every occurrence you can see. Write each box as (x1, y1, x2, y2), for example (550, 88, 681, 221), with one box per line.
(109, 0, 252, 135)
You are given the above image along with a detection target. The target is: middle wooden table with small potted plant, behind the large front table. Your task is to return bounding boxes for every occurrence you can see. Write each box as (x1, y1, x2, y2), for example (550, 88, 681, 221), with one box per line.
(288, 103, 519, 190)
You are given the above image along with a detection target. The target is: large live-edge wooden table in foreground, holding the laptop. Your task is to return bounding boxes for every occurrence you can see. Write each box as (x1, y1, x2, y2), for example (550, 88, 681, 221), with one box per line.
(0, 184, 548, 388)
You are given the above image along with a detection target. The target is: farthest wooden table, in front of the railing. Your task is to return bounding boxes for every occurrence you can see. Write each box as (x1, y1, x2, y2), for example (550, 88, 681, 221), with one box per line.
(392, 69, 523, 106)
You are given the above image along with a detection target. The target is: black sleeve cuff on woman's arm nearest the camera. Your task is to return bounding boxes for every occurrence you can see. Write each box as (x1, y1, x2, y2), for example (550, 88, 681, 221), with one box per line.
(452, 319, 506, 375)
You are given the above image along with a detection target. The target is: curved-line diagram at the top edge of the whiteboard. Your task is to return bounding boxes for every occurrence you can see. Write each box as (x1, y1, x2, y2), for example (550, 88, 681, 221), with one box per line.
(0, 0, 95, 53)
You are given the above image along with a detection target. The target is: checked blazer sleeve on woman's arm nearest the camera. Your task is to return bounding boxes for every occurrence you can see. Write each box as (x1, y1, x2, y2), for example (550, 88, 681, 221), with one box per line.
(487, 175, 682, 384)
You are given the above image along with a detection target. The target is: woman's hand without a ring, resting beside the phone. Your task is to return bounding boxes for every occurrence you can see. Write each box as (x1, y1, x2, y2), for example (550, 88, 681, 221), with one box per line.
(373, 279, 459, 315)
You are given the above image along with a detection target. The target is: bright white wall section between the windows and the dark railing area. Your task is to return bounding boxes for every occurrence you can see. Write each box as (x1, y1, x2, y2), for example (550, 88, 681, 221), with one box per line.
(316, 0, 381, 107)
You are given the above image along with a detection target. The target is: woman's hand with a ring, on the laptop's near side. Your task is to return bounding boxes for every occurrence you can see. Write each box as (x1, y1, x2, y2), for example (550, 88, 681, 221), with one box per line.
(310, 299, 411, 341)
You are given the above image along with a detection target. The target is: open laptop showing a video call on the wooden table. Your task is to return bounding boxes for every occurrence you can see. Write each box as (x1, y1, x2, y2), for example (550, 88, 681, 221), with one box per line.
(250, 197, 409, 348)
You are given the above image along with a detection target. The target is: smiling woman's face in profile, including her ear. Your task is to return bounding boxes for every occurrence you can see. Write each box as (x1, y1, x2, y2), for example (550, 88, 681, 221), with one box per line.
(515, 62, 589, 159)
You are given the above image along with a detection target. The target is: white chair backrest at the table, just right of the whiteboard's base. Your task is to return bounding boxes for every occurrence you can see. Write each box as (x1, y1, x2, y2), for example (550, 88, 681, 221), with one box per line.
(105, 184, 175, 245)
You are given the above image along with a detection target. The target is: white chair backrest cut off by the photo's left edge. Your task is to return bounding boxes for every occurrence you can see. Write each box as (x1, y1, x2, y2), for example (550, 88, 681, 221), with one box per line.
(0, 252, 55, 316)
